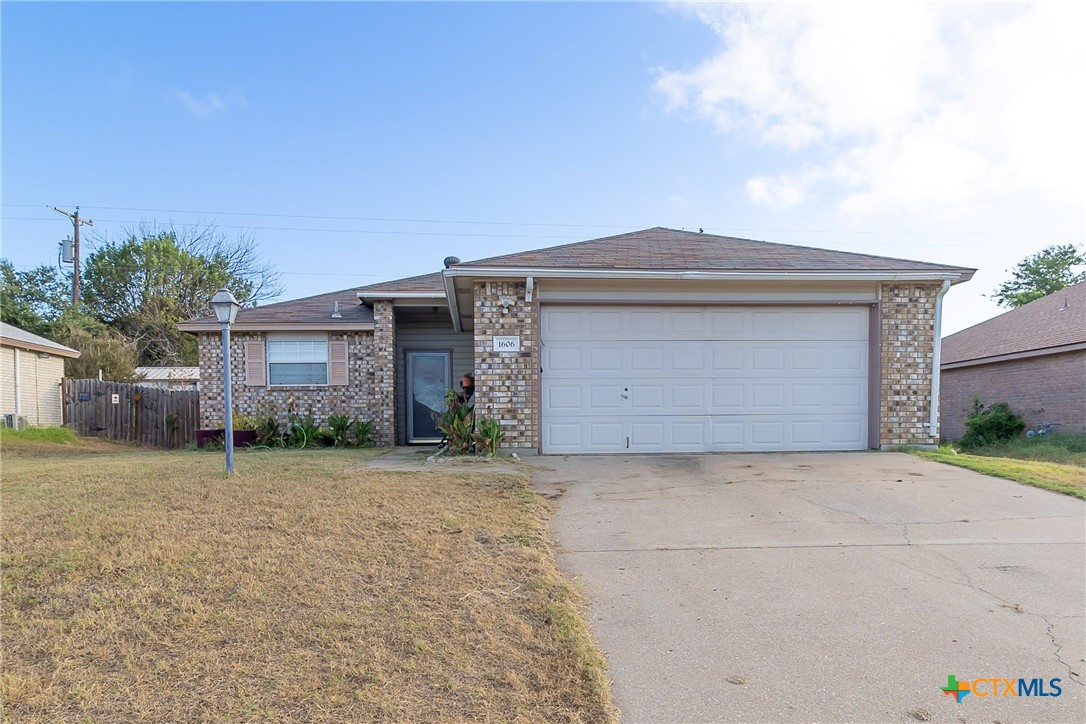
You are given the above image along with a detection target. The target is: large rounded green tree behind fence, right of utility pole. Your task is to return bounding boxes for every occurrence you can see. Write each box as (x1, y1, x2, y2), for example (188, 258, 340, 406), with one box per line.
(83, 226, 282, 365)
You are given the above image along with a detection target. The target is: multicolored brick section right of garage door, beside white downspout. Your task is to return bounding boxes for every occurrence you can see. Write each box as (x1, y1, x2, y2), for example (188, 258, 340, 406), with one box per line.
(879, 283, 942, 449)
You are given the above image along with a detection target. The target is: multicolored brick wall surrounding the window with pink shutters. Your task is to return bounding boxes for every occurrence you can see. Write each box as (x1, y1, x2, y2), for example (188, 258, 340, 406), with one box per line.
(199, 332, 380, 434)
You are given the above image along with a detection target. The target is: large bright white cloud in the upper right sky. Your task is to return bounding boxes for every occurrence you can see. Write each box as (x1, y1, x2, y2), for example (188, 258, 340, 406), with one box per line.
(656, 2, 1086, 217)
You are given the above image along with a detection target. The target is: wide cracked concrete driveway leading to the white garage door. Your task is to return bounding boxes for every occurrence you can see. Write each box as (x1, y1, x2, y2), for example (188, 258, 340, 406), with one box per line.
(532, 453, 1086, 722)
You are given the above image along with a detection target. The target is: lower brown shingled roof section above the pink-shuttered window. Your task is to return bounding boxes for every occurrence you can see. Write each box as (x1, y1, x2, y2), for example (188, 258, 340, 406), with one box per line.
(177, 288, 374, 332)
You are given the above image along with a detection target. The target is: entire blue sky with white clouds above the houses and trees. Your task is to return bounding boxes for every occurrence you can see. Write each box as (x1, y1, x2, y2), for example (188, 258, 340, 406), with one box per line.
(0, 2, 1084, 331)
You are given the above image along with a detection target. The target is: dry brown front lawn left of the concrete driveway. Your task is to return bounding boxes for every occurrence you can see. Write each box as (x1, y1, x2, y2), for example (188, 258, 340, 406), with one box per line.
(0, 438, 616, 722)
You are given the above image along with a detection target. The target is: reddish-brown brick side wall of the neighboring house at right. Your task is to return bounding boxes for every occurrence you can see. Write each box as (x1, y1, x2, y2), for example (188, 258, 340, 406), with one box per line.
(939, 351, 1086, 440)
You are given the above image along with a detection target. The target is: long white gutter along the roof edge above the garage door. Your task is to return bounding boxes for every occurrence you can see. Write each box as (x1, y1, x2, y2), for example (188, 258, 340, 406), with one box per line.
(443, 266, 963, 283)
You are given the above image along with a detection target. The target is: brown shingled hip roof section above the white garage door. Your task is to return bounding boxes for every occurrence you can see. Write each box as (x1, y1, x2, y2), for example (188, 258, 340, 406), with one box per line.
(455, 227, 975, 279)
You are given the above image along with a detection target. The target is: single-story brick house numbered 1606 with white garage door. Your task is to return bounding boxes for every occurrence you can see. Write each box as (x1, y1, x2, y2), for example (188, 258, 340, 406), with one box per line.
(180, 228, 974, 454)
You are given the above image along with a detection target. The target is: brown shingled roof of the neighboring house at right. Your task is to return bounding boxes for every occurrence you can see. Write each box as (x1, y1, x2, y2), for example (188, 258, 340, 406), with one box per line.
(940, 281, 1086, 367)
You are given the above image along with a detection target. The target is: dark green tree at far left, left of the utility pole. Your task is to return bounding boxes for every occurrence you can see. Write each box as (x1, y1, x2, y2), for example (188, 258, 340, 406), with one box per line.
(0, 259, 72, 336)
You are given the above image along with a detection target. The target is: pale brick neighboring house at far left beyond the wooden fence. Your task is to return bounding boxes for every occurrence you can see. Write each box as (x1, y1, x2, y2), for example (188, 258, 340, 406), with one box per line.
(0, 322, 80, 427)
